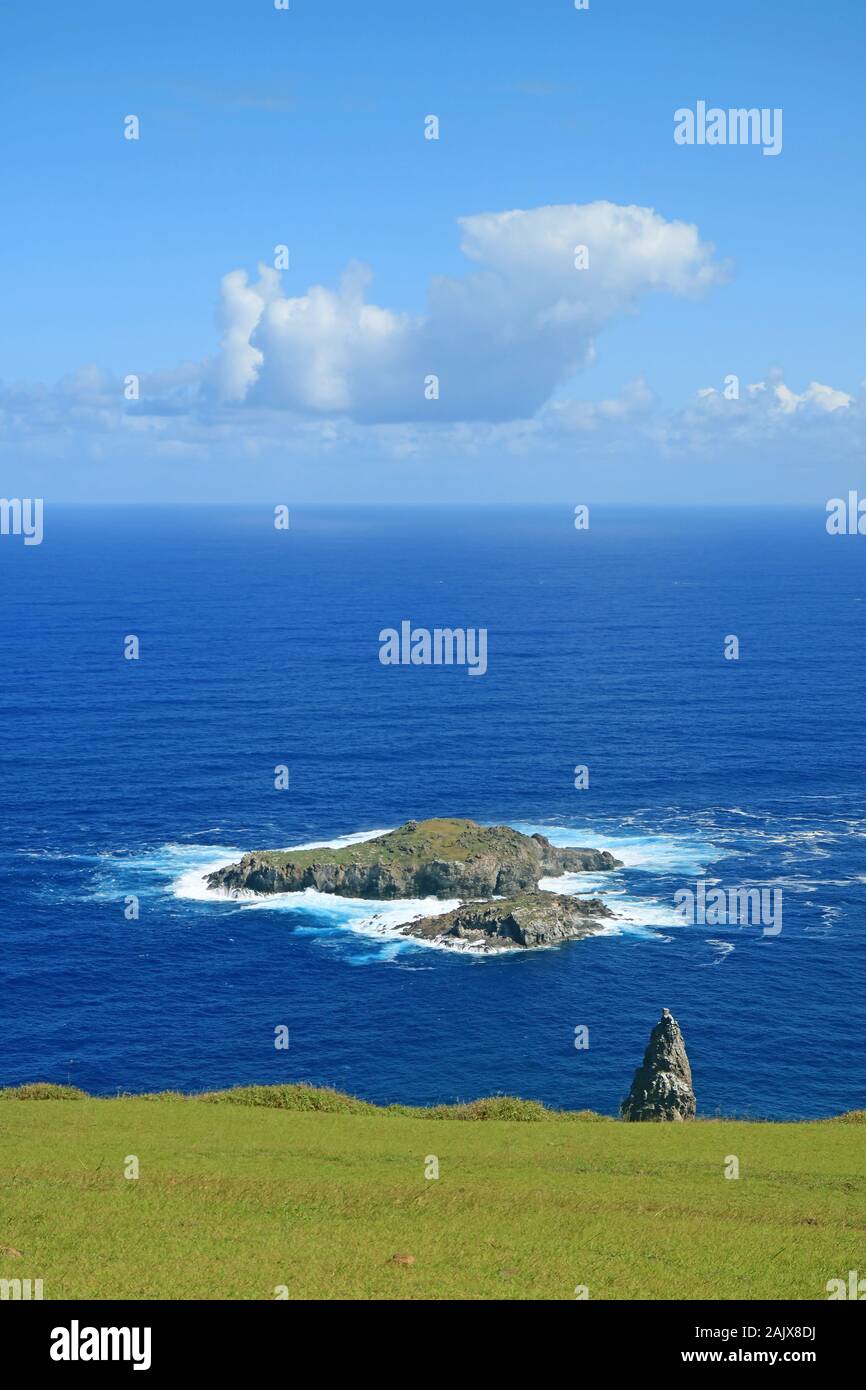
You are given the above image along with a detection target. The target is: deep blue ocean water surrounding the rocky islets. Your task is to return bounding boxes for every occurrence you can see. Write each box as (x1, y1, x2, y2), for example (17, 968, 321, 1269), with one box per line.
(0, 507, 866, 1118)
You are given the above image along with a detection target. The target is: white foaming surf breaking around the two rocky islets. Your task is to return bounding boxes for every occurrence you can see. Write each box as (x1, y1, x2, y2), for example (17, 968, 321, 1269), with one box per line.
(167, 823, 723, 958)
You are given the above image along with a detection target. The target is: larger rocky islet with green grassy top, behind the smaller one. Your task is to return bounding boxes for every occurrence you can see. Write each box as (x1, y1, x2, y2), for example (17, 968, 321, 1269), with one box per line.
(207, 820, 619, 899)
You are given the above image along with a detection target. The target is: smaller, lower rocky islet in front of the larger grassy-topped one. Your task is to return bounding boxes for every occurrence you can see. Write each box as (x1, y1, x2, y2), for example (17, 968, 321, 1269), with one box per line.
(400, 892, 613, 951)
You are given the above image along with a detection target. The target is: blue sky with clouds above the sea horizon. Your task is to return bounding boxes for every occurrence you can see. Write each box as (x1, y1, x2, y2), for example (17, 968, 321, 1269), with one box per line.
(0, 0, 866, 502)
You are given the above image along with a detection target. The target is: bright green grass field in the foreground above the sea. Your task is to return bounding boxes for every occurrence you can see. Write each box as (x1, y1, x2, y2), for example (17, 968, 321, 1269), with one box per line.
(0, 1087, 866, 1300)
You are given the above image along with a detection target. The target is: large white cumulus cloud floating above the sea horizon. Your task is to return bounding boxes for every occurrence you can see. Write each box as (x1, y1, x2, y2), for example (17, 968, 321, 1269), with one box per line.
(210, 202, 724, 423)
